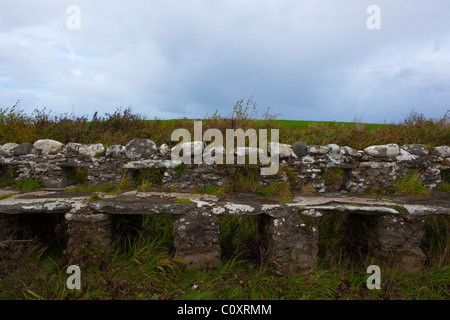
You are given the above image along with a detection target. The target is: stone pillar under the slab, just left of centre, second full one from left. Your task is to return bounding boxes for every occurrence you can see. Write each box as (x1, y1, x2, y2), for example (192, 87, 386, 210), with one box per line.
(173, 208, 220, 269)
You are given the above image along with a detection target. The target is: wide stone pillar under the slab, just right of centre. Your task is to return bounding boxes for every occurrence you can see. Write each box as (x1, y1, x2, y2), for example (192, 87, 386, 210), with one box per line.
(260, 209, 321, 274)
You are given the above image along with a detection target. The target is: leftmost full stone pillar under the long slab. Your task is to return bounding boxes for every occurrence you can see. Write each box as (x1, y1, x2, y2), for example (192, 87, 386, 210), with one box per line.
(65, 206, 113, 266)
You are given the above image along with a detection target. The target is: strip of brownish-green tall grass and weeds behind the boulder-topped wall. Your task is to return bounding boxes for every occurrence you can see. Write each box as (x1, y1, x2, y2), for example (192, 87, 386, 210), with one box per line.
(0, 98, 450, 149)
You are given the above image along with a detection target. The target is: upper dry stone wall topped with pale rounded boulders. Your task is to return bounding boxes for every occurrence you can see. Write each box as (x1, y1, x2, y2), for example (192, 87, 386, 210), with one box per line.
(0, 139, 450, 193)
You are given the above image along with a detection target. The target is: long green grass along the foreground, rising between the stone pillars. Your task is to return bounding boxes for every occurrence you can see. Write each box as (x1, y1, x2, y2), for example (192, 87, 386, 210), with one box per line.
(0, 214, 450, 300)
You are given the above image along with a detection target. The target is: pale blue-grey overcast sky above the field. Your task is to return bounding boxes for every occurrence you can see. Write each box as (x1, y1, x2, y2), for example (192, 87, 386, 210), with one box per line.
(0, 0, 450, 123)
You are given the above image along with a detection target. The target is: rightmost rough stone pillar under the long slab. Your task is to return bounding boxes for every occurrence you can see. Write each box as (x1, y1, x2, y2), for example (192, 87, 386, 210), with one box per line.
(376, 214, 425, 272)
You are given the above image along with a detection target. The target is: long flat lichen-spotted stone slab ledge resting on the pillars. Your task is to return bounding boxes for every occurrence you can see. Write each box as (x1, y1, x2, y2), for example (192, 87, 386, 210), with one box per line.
(0, 190, 450, 217)
